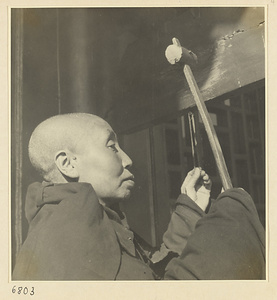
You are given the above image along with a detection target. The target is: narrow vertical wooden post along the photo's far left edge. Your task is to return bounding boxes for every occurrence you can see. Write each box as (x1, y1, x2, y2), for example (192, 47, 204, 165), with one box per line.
(11, 9, 23, 264)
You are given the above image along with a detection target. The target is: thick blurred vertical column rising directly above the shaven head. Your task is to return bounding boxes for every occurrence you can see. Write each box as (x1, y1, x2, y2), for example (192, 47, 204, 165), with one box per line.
(57, 8, 99, 114)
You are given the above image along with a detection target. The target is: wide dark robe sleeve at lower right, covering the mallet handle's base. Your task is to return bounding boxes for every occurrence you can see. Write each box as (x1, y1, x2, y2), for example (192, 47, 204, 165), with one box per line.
(165, 188, 265, 280)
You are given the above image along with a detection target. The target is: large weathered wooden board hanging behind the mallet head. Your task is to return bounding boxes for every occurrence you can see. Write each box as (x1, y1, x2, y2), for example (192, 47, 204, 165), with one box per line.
(115, 7, 265, 132)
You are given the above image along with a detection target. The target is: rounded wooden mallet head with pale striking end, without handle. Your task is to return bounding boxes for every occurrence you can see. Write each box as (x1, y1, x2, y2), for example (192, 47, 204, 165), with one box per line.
(165, 38, 197, 66)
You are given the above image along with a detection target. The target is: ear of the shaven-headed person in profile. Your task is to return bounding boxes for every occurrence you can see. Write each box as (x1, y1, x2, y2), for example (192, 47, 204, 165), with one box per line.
(55, 150, 79, 179)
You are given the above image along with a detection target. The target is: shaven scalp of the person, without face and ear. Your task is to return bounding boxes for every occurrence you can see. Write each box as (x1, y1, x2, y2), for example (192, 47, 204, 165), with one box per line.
(29, 113, 107, 182)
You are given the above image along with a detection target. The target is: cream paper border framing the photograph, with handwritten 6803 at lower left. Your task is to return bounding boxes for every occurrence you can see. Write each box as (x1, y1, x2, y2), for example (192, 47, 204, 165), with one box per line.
(0, 0, 277, 300)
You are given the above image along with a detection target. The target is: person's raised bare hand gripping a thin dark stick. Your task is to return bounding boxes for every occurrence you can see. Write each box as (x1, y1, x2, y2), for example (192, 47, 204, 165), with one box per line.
(181, 167, 212, 211)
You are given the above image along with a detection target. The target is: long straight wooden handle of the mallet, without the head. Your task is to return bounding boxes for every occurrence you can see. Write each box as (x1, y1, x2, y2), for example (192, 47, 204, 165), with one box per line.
(183, 65, 233, 190)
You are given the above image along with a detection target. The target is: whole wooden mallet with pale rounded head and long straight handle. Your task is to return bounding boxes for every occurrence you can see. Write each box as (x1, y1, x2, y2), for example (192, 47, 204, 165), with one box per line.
(165, 38, 233, 190)
